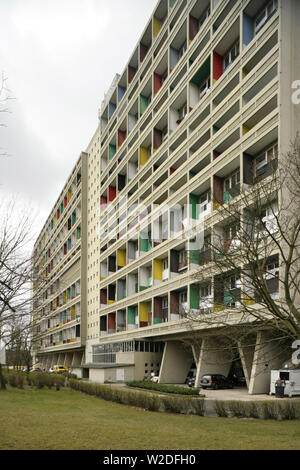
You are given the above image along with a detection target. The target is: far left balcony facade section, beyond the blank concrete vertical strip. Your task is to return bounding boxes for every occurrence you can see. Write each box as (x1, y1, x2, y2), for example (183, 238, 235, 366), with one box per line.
(32, 153, 88, 373)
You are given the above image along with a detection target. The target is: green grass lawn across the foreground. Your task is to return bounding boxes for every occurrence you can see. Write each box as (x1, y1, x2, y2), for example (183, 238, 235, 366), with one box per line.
(0, 387, 300, 450)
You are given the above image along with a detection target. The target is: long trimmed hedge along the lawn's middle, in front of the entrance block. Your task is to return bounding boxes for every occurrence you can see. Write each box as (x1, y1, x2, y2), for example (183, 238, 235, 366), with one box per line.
(68, 379, 204, 416)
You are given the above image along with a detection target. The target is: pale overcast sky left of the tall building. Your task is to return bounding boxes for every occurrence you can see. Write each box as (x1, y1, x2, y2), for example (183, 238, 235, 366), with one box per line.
(0, 0, 157, 241)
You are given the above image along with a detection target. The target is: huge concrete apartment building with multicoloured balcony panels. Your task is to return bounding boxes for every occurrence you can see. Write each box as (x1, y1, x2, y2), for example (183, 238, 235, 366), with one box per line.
(34, 0, 300, 393)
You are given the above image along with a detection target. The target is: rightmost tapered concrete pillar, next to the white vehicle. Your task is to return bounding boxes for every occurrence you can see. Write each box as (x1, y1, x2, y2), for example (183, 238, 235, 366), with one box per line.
(249, 331, 284, 395)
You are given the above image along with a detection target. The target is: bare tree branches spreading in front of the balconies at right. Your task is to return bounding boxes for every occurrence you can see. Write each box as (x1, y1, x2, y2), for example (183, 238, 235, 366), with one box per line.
(187, 135, 300, 360)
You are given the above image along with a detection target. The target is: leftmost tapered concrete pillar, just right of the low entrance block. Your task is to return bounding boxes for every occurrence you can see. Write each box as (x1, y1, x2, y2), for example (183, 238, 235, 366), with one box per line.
(159, 341, 193, 384)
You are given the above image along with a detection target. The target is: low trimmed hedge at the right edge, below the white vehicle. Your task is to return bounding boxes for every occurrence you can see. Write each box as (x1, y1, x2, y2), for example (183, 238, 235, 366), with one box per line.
(214, 399, 300, 420)
